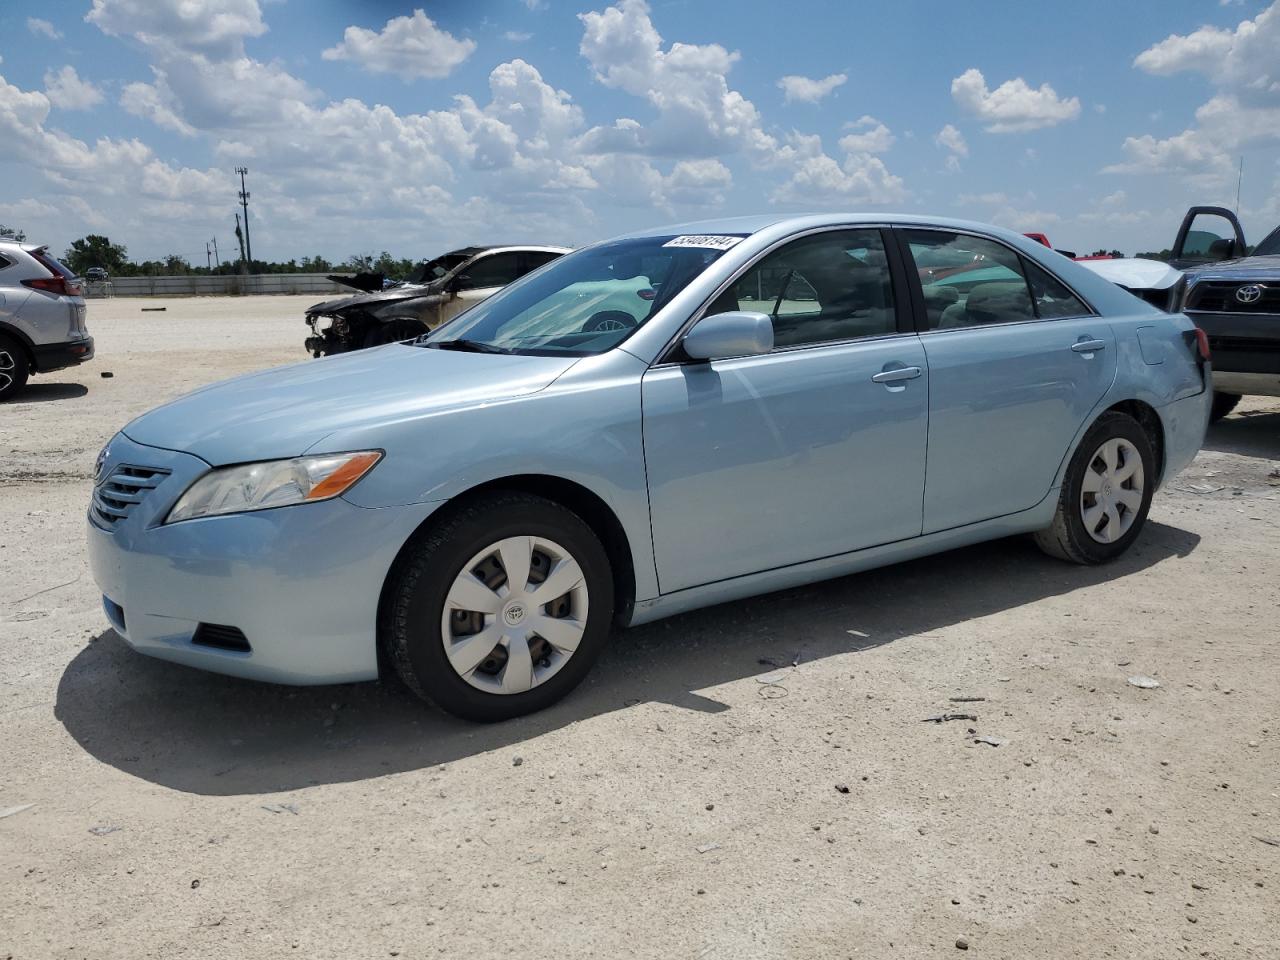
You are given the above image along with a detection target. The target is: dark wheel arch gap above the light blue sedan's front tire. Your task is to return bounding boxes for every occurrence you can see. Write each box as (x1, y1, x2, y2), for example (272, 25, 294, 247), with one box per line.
(378, 474, 636, 676)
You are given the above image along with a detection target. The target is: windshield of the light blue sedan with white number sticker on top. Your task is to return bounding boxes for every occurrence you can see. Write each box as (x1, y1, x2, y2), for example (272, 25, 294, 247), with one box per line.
(419, 236, 742, 356)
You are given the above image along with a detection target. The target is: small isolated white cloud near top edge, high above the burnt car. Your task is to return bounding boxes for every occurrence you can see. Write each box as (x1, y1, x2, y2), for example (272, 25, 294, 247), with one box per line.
(320, 10, 476, 82)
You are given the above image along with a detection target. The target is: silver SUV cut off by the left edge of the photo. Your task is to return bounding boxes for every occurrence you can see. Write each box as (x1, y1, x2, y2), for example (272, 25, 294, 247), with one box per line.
(0, 237, 93, 401)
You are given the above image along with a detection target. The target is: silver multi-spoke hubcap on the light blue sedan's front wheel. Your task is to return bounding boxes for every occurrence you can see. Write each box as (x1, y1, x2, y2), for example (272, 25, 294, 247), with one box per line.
(440, 536, 588, 694)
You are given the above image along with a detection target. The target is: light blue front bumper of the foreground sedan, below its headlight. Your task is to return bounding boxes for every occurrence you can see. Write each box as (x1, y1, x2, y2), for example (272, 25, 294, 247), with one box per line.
(88, 434, 439, 684)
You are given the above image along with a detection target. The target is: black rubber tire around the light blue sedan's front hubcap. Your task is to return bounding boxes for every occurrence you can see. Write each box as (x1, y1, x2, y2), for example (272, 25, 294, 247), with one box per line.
(380, 492, 613, 723)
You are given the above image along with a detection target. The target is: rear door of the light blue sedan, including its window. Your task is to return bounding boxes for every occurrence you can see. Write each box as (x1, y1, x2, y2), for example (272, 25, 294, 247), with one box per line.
(897, 229, 1116, 534)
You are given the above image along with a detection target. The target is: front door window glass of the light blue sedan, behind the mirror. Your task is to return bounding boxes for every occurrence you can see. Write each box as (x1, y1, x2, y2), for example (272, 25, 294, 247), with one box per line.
(707, 229, 897, 348)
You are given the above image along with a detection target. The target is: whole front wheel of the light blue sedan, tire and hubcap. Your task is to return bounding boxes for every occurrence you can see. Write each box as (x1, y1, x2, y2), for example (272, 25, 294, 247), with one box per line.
(383, 493, 613, 722)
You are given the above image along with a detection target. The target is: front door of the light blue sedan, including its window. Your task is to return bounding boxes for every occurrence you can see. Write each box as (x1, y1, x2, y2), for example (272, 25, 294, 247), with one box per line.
(643, 229, 928, 593)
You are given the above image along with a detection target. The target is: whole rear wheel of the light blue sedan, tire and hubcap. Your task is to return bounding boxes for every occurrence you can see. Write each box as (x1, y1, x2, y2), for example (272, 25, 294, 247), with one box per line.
(1036, 412, 1156, 564)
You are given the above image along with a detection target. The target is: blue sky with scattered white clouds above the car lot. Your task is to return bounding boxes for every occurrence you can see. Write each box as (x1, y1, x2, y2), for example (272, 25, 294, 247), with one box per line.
(0, 0, 1280, 262)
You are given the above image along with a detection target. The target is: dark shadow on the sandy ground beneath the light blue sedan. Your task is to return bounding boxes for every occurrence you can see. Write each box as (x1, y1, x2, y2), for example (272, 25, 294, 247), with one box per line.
(55, 522, 1199, 795)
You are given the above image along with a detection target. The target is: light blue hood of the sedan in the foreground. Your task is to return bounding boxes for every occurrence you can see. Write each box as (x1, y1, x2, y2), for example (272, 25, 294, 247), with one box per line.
(124, 343, 577, 466)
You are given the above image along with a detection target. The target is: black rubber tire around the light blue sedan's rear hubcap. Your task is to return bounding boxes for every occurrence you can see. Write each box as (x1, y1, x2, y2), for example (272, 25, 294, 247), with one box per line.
(1036, 411, 1157, 564)
